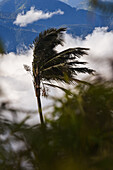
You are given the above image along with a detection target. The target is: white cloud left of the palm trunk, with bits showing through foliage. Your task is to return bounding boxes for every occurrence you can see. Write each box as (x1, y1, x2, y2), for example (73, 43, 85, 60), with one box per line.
(0, 50, 58, 123)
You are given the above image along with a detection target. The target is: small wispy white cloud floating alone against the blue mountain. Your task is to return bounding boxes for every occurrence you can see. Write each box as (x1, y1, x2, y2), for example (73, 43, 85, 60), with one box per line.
(13, 7, 64, 27)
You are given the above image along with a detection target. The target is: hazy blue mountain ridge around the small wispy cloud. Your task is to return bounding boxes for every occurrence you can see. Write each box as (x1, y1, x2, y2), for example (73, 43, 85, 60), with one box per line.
(0, 0, 109, 52)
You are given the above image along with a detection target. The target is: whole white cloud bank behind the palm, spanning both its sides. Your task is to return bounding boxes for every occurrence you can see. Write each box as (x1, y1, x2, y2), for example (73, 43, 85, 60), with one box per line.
(0, 27, 113, 121)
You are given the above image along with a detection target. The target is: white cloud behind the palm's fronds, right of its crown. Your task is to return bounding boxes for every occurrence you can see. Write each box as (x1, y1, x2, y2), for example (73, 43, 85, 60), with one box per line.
(57, 27, 113, 79)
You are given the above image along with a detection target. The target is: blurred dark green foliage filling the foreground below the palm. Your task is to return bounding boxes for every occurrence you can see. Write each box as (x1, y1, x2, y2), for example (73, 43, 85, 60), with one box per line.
(0, 82, 113, 170)
